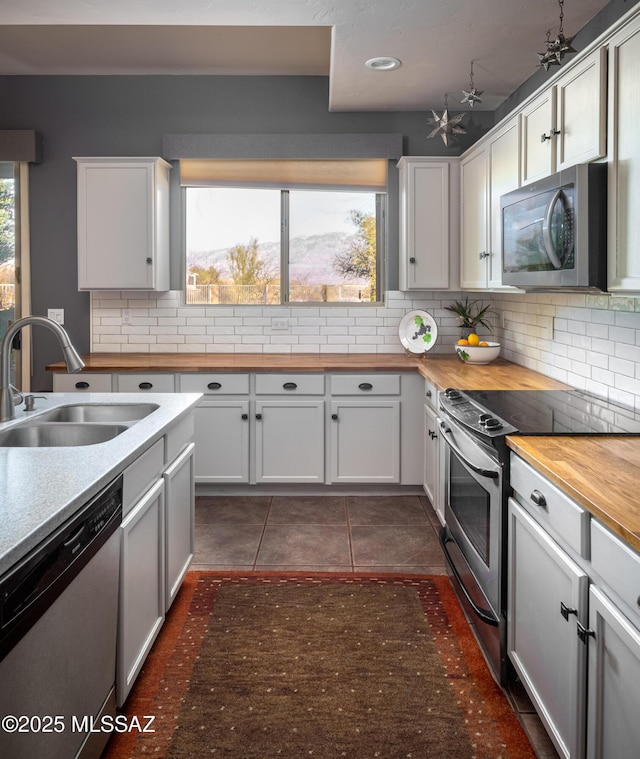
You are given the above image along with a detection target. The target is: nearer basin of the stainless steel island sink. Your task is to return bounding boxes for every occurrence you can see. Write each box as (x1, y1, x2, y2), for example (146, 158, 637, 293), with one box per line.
(0, 422, 128, 448)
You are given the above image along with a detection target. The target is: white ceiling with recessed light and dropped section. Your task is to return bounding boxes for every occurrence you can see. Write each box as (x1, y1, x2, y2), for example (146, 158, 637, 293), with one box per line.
(0, 0, 607, 111)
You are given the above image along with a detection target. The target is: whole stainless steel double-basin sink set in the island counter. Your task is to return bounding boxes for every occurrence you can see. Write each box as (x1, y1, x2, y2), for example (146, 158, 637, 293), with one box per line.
(0, 403, 158, 448)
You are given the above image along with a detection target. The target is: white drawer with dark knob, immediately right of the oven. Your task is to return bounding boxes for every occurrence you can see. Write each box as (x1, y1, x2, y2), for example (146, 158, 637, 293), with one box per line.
(511, 455, 589, 559)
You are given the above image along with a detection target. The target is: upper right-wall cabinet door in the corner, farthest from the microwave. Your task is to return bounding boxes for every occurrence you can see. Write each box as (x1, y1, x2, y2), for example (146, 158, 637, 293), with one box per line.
(460, 148, 489, 289)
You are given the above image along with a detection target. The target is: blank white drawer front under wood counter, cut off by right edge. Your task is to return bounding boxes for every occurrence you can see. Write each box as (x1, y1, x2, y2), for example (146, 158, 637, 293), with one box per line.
(591, 519, 640, 624)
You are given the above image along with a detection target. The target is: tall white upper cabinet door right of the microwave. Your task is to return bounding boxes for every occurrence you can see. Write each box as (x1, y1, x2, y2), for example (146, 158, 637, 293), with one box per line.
(608, 19, 640, 292)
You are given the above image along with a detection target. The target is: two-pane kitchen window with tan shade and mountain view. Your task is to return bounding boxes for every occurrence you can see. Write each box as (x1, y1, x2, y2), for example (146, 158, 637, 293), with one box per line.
(180, 160, 387, 306)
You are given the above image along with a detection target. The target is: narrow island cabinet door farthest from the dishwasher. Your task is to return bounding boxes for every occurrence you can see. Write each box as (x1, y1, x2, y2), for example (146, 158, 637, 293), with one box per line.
(163, 443, 195, 611)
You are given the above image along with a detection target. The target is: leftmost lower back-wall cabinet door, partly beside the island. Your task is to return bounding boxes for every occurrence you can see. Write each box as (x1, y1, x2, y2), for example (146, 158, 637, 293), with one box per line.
(194, 399, 249, 482)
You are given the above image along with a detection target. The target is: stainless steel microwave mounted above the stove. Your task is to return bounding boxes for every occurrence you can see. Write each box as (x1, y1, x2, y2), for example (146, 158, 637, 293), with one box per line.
(500, 163, 607, 290)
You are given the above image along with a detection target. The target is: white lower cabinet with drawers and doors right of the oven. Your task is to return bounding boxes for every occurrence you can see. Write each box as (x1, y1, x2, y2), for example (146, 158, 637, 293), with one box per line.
(507, 456, 640, 759)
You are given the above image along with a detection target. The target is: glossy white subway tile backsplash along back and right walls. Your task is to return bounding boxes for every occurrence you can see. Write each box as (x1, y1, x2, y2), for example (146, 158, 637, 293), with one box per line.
(91, 291, 640, 410)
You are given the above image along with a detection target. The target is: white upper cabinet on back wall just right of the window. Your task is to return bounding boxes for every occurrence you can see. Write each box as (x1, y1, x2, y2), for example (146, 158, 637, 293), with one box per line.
(398, 156, 457, 291)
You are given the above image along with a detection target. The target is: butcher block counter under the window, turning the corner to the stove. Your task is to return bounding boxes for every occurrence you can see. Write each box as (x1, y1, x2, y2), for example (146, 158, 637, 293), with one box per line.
(47, 353, 567, 390)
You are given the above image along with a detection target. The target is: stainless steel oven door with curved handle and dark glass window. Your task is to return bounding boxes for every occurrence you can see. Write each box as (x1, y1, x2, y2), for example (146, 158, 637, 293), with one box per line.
(440, 417, 503, 626)
